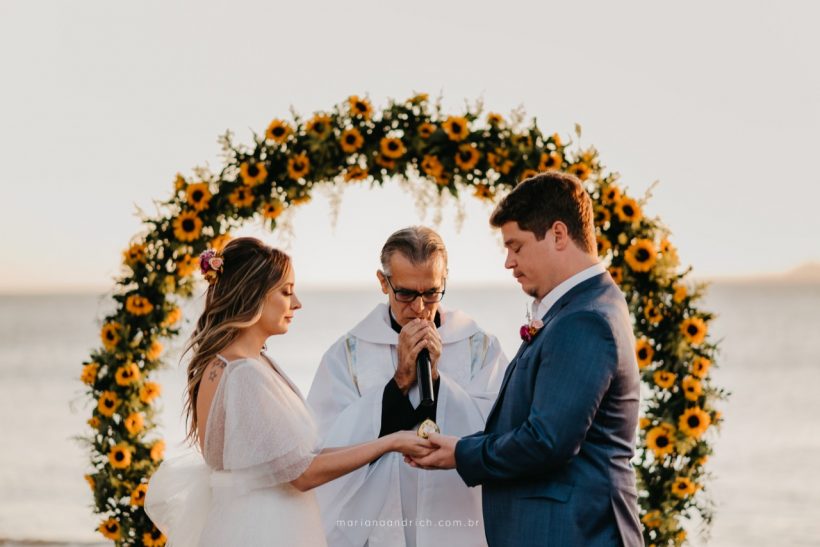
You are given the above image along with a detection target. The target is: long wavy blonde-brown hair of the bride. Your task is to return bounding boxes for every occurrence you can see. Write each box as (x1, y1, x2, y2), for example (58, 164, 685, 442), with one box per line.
(183, 237, 291, 443)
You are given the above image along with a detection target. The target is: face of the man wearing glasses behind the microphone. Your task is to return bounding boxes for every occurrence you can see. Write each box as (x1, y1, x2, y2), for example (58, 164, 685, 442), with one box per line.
(376, 252, 447, 327)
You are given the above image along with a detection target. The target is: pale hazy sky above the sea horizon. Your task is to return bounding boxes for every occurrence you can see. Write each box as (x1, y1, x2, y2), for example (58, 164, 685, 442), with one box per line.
(0, 0, 820, 292)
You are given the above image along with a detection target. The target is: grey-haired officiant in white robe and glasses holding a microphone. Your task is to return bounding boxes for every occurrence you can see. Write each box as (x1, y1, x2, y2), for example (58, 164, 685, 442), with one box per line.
(307, 226, 508, 547)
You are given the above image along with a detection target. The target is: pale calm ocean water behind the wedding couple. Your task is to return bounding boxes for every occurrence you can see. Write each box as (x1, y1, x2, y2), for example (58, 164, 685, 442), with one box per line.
(0, 282, 820, 547)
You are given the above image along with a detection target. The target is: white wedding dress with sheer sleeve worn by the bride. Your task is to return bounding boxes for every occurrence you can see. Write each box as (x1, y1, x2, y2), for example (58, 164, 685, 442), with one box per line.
(145, 357, 326, 547)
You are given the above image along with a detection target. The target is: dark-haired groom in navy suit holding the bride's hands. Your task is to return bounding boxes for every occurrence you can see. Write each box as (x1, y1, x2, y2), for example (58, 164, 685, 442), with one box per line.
(408, 172, 643, 547)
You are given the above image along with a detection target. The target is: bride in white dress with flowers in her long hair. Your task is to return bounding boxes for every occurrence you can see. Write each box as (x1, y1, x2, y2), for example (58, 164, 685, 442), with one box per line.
(145, 238, 432, 547)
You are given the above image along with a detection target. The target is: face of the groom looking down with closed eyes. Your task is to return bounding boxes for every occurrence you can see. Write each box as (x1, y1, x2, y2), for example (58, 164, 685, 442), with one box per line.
(501, 222, 555, 298)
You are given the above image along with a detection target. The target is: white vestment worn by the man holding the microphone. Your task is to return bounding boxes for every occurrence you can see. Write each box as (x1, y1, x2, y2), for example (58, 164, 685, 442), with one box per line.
(307, 304, 508, 547)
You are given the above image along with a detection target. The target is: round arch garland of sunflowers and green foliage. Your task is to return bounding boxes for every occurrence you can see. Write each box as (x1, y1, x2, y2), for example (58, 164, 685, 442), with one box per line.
(81, 94, 725, 546)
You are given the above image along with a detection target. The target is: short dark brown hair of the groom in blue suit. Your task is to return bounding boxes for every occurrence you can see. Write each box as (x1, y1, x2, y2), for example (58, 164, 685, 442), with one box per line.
(490, 171, 597, 254)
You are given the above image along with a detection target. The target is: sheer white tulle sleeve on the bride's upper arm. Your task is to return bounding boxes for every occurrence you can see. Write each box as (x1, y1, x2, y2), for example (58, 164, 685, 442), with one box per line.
(223, 360, 318, 483)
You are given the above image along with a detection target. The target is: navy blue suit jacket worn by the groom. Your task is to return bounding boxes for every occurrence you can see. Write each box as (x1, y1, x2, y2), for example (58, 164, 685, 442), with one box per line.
(456, 273, 643, 547)
